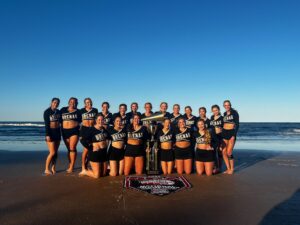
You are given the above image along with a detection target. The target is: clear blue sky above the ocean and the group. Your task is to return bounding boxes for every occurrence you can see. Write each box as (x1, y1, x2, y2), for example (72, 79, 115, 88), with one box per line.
(0, 0, 300, 122)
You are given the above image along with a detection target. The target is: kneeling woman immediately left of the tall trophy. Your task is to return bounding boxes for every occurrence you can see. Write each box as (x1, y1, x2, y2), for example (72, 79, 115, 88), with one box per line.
(124, 114, 149, 176)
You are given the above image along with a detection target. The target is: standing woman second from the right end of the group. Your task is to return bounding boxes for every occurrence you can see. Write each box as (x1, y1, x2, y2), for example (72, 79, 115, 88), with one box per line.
(210, 105, 223, 173)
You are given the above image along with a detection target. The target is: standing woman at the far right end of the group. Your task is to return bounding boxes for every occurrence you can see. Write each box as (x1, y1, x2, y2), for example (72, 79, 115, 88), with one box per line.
(222, 100, 240, 174)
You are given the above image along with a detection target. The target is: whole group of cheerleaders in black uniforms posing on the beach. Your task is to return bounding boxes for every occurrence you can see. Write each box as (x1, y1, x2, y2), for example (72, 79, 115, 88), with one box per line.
(44, 97, 239, 178)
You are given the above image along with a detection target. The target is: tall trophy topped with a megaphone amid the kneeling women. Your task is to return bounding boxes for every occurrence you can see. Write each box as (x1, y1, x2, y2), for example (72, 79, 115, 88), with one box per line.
(141, 113, 165, 175)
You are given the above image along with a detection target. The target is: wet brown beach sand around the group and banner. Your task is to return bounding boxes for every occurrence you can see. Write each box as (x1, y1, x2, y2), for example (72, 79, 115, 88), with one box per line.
(0, 150, 300, 225)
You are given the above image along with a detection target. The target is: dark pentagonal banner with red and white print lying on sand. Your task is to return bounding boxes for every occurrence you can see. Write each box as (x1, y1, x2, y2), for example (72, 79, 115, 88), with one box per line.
(124, 176, 192, 196)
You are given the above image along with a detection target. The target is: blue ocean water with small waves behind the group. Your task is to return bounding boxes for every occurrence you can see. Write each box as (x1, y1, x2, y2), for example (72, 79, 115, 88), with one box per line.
(0, 122, 300, 151)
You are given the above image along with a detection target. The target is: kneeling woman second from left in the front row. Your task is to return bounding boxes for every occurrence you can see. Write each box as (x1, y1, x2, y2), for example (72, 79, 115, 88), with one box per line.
(108, 117, 127, 177)
